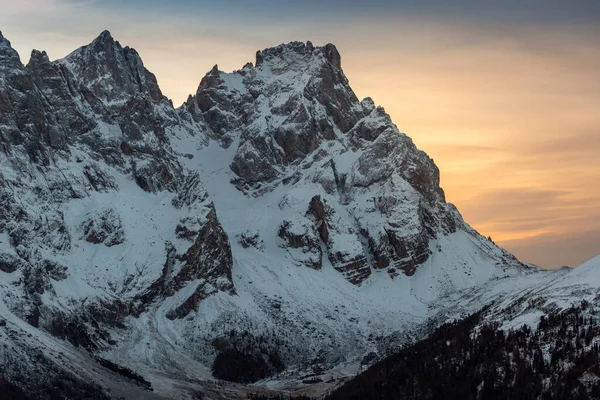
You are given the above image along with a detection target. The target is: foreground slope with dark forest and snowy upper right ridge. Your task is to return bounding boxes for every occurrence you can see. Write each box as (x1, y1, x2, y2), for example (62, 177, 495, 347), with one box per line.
(326, 256, 600, 400)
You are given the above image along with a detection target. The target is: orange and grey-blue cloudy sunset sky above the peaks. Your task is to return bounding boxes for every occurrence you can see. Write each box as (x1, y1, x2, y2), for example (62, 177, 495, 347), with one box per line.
(0, 0, 600, 268)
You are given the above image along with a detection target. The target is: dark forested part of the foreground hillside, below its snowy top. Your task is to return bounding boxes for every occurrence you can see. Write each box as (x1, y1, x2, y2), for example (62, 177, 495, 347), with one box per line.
(327, 302, 600, 400)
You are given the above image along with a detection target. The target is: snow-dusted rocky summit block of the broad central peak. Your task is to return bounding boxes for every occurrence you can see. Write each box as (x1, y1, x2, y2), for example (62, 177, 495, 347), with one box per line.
(183, 42, 363, 191)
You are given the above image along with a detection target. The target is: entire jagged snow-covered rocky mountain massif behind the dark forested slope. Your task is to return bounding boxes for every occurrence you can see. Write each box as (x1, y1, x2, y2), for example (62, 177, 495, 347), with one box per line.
(0, 31, 600, 398)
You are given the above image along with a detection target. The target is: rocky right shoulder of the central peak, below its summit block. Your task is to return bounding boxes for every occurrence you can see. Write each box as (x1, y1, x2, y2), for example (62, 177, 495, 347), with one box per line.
(344, 108, 464, 275)
